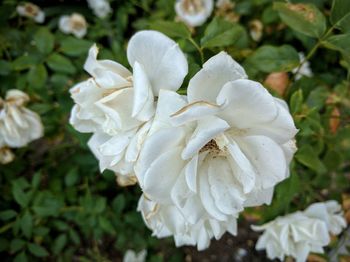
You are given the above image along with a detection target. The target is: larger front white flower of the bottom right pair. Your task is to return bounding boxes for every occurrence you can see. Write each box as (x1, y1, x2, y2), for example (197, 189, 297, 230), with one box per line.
(252, 212, 330, 262)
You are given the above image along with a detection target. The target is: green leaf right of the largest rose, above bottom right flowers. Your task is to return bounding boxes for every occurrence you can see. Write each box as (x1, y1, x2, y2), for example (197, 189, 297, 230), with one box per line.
(295, 145, 327, 174)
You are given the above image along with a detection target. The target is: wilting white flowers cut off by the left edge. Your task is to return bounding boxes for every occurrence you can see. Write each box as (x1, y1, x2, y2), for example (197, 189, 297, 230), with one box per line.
(0, 89, 43, 164)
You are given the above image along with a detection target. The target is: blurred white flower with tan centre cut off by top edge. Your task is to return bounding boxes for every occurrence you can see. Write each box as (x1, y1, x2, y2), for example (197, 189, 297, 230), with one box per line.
(175, 0, 214, 27)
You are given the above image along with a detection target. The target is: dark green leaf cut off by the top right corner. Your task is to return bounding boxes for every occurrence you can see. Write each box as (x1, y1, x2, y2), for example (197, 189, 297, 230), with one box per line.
(331, 0, 350, 32)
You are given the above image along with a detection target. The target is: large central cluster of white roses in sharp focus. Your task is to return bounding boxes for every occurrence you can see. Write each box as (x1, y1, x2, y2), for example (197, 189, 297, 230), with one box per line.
(70, 31, 297, 250)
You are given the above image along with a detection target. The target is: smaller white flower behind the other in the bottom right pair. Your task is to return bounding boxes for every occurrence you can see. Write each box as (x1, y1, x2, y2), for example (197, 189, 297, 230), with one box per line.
(304, 200, 346, 235)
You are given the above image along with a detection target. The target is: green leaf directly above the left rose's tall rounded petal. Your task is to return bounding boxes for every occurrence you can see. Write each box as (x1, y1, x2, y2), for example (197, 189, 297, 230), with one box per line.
(150, 21, 191, 38)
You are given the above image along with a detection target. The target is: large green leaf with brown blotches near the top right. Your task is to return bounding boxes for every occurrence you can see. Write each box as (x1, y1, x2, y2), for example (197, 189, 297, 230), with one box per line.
(273, 2, 326, 38)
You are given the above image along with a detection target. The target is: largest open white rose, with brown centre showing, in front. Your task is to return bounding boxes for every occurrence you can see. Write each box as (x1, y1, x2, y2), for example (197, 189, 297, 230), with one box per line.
(135, 52, 297, 249)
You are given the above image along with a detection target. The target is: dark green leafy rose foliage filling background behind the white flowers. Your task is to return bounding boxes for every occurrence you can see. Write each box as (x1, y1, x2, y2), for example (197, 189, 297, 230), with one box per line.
(0, 0, 350, 261)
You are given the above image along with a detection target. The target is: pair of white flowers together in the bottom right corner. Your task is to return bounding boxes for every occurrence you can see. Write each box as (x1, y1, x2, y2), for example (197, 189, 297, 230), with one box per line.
(252, 201, 346, 262)
